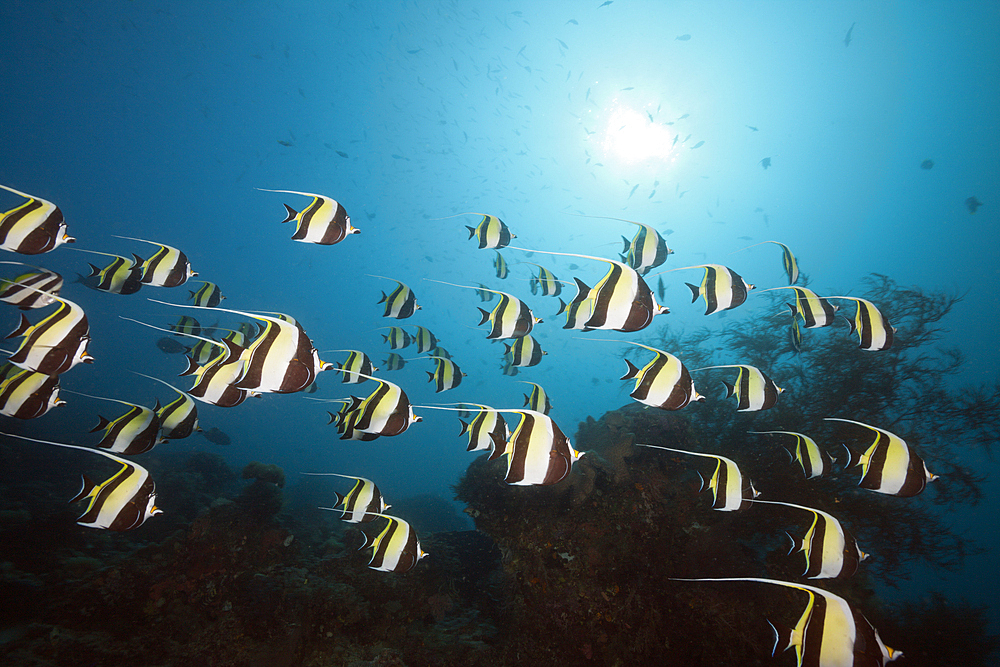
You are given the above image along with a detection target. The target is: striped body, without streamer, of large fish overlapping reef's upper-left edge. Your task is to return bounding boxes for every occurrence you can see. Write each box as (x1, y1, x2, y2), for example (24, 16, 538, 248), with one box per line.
(504, 410, 582, 486)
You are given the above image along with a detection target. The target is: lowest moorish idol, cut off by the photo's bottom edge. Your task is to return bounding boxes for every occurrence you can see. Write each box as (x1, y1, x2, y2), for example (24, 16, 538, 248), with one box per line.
(675, 577, 903, 667)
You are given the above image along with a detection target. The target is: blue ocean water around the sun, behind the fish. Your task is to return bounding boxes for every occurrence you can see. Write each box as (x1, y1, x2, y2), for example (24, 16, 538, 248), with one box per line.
(0, 0, 1000, 664)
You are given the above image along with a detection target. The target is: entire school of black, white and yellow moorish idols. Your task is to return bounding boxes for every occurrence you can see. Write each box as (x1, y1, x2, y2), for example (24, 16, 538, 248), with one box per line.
(0, 171, 937, 667)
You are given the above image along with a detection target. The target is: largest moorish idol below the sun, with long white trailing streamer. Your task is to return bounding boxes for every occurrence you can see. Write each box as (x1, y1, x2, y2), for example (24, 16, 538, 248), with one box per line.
(513, 248, 670, 332)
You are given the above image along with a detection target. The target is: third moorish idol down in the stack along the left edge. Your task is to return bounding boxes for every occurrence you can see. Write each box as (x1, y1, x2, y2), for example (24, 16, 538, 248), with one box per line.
(7, 293, 94, 375)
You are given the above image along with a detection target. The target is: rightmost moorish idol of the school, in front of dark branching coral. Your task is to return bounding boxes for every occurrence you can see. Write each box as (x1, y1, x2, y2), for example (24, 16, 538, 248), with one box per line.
(825, 417, 938, 498)
